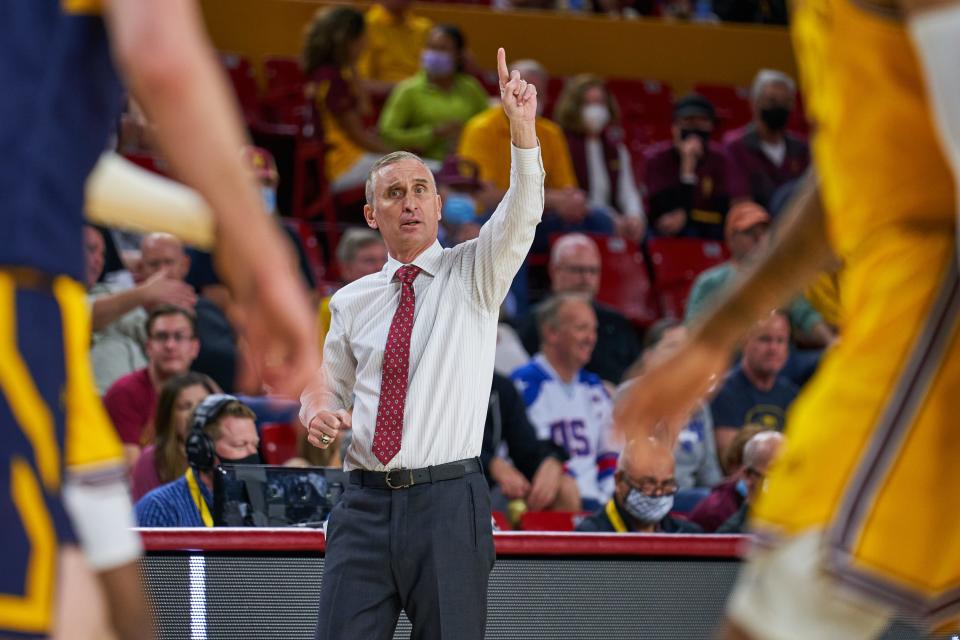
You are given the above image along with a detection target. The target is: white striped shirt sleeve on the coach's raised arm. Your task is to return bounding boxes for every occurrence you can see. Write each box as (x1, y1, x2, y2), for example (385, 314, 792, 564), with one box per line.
(461, 145, 546, 311)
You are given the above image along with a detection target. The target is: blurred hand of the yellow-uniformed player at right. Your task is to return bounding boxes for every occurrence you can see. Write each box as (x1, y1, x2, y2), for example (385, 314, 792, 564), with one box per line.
(614, 338, 730, 447)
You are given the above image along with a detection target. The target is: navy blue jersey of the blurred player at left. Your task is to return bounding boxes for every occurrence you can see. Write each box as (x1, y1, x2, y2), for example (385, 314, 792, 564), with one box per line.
(0, 0, 122, 282)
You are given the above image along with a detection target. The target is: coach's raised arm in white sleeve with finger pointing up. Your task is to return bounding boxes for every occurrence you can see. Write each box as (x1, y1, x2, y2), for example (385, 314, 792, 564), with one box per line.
(469, 48, 544, 311)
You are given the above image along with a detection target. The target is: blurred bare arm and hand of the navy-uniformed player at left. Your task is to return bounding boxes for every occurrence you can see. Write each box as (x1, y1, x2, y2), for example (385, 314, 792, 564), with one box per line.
(105, 0, 317, 395)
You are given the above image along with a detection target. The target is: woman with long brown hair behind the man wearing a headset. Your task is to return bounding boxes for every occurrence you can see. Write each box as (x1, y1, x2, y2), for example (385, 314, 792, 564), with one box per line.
(130, 372, 220, 502)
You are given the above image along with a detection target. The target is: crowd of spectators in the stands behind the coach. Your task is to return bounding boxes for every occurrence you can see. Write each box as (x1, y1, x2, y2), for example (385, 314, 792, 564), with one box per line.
(94, 0, 828, 533)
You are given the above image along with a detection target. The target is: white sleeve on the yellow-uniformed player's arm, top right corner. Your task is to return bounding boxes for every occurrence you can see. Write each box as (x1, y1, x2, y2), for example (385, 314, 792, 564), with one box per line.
(900, 0, 960, 255)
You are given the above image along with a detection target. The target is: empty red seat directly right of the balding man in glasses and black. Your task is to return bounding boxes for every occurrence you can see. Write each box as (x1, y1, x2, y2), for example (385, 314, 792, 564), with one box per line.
(593, 235, 660, 327)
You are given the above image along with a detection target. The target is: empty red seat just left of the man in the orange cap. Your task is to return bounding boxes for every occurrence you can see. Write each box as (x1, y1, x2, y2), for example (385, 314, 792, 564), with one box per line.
(647, 238, 728, 319)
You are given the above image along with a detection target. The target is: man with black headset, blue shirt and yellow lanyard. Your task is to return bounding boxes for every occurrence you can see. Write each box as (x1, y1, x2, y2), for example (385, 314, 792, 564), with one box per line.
(135, 394, 260, 527)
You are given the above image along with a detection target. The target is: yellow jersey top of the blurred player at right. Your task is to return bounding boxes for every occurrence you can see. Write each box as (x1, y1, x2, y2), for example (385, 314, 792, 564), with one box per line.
(792, 0, 956, 257)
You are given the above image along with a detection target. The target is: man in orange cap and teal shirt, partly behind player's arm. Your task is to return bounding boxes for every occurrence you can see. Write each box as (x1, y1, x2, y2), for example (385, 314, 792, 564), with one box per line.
(685, 202, 834, 347)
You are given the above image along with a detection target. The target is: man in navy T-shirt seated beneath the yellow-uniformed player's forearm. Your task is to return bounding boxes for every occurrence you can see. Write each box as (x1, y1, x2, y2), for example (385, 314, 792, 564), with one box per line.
(710, 311, 799, 451)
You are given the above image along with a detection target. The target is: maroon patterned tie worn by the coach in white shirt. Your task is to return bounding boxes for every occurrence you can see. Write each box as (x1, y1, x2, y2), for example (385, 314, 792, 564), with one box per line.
(373, 265, 420, 464)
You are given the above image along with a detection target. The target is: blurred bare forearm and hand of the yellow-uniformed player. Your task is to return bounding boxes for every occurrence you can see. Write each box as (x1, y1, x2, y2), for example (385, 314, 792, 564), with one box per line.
(616, 172, 833, 442)
